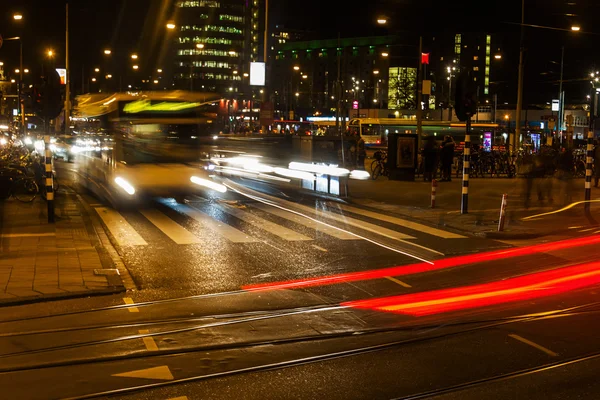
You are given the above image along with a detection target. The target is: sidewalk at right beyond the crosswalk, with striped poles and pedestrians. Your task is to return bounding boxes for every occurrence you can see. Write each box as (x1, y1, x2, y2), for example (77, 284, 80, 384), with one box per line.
(349, 178, 600, 239)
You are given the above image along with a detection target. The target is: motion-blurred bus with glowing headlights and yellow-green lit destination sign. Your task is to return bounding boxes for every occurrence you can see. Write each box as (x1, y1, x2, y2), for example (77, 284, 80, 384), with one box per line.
(75, 91, 224, 206)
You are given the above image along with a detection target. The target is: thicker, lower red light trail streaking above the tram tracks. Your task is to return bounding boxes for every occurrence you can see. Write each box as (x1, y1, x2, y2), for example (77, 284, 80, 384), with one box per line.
(342, 262, 600, 316)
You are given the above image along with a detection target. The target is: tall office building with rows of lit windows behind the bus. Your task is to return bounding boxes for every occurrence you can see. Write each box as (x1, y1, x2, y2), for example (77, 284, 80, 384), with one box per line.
(173, 0, 264, 95)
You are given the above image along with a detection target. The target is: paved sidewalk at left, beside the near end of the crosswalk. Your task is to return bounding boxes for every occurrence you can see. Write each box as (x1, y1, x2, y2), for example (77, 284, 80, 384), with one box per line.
(0, 190, 124, 305)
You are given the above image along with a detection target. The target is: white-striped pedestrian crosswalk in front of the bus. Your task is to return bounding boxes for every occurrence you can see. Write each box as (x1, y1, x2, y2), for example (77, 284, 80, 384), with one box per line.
(95, 201, 464, 247)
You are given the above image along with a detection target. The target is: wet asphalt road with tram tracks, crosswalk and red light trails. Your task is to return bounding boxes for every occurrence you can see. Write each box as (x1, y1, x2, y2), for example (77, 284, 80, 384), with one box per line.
(0, 159, 600, 400)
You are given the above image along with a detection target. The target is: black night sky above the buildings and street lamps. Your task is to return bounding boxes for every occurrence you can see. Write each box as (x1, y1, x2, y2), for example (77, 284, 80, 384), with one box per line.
(0, 0, 600, 101)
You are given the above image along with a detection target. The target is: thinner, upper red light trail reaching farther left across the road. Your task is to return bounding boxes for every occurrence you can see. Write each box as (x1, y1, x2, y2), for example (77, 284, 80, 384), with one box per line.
(242, 235, 600, 291)
